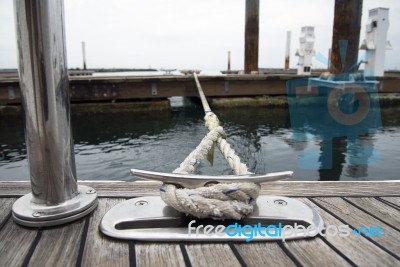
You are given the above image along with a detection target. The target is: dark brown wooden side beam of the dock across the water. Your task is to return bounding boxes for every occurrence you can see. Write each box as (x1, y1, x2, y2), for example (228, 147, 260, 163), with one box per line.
(0, 71, 400, 106)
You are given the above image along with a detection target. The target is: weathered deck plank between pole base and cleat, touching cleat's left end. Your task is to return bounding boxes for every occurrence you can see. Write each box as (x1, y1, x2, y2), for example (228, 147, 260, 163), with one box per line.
(82, 198, 129, 266)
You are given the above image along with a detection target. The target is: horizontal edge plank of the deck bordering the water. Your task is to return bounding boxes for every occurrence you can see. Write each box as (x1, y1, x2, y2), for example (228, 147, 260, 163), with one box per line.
(0, 181, 400, 197)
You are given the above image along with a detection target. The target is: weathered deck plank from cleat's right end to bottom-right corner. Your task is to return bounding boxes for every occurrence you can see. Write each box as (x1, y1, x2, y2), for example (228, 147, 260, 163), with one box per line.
(300, 198, 400, 266)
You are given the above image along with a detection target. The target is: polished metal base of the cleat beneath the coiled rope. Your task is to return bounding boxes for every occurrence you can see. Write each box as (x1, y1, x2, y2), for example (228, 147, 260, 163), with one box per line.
(100, 196, 324, 242)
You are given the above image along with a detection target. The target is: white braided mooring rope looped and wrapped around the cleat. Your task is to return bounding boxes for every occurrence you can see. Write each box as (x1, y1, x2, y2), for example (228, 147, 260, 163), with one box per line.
(160, 73, 260, 220)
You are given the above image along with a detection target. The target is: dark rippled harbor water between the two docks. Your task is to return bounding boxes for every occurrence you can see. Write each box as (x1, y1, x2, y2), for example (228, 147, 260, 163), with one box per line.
(0, 98, 400, 181)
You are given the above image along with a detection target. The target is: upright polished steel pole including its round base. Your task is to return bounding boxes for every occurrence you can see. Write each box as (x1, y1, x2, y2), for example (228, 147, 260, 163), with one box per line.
(13, 0, 97, 227)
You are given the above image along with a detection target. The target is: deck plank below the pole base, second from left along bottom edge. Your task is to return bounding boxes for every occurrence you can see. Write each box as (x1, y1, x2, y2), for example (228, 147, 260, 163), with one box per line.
(28, 219, 85, 267)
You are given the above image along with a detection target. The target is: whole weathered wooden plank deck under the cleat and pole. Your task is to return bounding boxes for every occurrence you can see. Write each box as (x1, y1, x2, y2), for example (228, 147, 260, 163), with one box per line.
(0, 181, 400, 267)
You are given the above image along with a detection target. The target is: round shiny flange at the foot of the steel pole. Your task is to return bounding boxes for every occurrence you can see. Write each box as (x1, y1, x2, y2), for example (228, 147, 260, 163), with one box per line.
(12, 185, 98, 227)
